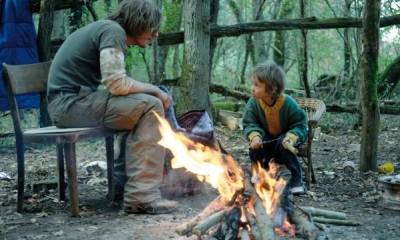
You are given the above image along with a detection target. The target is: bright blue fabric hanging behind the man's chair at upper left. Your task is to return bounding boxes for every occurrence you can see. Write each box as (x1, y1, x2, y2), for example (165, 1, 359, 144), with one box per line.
(0, 0, 39, 111)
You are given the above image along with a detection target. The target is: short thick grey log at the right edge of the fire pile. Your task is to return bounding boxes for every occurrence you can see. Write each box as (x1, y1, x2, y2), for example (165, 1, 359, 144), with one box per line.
(290, 208, 320, 240)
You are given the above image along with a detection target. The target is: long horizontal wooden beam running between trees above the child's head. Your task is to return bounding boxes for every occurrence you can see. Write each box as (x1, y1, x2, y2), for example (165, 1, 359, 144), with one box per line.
(158, 14, 400, 45)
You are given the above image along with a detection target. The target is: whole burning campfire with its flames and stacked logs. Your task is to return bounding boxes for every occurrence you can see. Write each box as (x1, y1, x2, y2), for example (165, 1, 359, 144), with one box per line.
(155, 114, 319, 240)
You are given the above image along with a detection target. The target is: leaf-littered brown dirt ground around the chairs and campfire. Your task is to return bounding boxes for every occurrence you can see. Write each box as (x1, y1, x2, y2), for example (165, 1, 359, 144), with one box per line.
(0, 114, 400, 240)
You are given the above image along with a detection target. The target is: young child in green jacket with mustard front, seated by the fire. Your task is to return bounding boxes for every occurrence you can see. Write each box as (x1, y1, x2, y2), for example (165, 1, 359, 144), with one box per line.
(243, 62, 307, 194)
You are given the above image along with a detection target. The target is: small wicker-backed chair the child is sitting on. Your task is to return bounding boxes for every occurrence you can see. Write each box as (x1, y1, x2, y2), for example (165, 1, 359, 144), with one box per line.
(295, 98, 326, 189)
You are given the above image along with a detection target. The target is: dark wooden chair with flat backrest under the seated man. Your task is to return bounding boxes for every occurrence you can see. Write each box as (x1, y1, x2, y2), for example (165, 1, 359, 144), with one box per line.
(3, 62, 114, 216)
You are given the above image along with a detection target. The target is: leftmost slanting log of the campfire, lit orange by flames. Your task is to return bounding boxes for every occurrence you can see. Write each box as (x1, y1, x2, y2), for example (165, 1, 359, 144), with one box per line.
(175, 196, 226, 235)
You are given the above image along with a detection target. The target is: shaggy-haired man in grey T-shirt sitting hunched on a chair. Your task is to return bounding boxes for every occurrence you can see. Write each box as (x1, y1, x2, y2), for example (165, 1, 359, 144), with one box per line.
(48, 0, 177, 214)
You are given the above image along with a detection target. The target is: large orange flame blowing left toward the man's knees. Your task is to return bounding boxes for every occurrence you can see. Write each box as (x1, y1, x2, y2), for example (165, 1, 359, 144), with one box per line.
(156, 114, 244, 201)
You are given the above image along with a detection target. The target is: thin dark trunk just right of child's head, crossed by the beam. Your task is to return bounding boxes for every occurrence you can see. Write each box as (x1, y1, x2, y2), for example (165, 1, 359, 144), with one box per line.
(298, 0, 311, 98)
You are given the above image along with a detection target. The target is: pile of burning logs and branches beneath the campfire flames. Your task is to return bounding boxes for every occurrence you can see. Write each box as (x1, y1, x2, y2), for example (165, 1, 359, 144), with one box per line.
(176, 167, 320, 240)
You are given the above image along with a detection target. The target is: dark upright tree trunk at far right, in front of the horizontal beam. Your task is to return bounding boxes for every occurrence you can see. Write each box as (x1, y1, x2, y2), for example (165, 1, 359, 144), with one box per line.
(360, 0, 381, 171)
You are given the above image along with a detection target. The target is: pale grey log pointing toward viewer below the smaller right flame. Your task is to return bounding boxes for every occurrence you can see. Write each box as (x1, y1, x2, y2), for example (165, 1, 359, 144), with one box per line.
(254, 196, 275, 240)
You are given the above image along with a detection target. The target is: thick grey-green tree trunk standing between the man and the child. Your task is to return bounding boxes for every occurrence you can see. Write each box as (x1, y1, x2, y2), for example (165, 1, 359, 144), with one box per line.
(178, 0, 210, 112)
